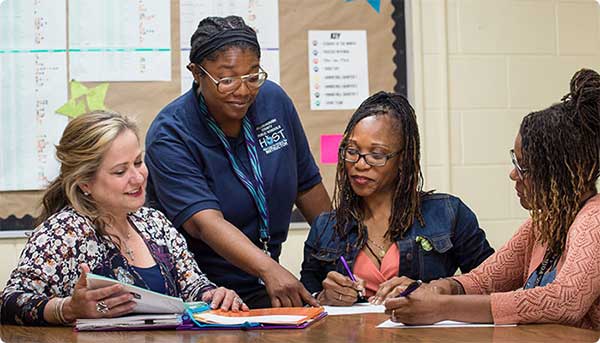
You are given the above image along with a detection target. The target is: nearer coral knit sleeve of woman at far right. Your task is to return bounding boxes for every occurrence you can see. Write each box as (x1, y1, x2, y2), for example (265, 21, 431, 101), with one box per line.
(491, 214, 600, 326)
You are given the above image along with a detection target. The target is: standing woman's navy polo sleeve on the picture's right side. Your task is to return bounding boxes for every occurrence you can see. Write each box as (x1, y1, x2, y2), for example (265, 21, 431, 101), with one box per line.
(288, 98, 321, 192)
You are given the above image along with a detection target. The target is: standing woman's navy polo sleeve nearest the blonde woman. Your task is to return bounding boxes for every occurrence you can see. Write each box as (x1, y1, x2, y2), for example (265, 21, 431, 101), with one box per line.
(145, 137, 221, 227)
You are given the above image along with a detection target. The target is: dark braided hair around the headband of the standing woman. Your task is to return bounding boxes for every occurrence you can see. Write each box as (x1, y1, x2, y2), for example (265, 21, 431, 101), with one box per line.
(190, 15, 260, 64)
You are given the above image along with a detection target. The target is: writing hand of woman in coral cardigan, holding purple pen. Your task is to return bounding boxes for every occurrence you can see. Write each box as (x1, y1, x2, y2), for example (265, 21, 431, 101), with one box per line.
(384, 286, 446, 325)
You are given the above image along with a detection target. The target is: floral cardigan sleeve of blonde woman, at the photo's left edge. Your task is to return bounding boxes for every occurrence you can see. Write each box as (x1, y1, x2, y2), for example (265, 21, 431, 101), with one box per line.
(0, 216, 89, 325)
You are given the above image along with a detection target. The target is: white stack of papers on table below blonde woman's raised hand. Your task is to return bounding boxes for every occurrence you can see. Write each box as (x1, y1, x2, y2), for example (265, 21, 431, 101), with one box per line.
(75, 314, 181, 331)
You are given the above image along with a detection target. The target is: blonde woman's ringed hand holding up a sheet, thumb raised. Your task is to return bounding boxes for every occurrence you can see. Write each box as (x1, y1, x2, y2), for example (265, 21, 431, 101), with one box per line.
(63, 263, 136, 322)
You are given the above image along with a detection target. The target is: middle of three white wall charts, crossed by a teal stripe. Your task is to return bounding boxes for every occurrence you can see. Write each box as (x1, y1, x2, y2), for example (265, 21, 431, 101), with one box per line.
(69, 0, 171, 81)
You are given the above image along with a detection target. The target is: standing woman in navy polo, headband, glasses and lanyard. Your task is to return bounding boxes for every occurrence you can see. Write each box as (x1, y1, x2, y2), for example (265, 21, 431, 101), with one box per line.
(146, 16, 331, 307)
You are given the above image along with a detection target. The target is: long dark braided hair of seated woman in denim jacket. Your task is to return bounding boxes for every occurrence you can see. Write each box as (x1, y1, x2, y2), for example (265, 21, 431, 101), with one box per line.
(333, 91, 425, 241)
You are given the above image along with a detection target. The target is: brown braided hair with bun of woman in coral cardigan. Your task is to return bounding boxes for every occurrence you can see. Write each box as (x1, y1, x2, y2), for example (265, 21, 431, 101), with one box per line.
(519, 69, 600, 255)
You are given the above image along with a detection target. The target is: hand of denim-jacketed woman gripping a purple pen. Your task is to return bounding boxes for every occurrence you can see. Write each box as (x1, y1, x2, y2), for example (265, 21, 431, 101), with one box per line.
(318, 271, 365, 306)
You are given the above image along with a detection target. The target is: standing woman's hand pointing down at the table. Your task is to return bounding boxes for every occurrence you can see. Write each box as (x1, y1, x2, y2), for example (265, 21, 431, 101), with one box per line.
(261, 264, 319, 307)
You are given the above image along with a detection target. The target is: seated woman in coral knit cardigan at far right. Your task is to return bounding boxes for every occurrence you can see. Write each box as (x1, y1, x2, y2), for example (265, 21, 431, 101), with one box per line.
(385, 69, 600, 330)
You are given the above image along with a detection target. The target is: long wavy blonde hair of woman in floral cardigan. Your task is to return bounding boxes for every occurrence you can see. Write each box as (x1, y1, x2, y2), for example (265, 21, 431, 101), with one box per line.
(38, 111, 139, 232)
